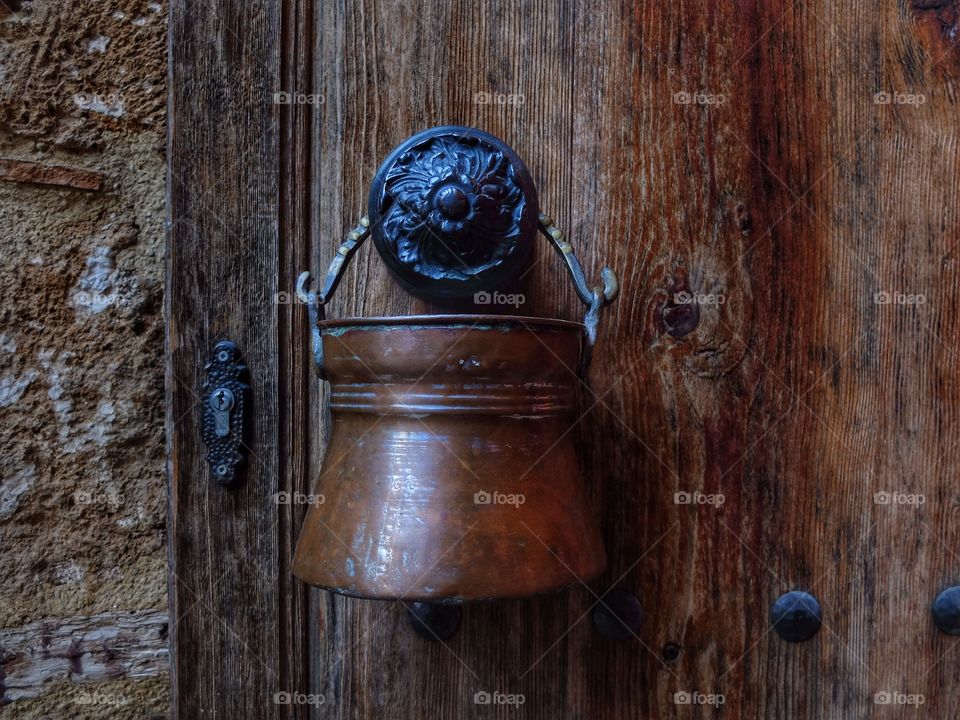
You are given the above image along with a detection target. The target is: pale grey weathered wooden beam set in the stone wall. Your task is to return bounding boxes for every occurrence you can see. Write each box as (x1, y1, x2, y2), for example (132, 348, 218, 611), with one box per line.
(0, 610, 169, 702)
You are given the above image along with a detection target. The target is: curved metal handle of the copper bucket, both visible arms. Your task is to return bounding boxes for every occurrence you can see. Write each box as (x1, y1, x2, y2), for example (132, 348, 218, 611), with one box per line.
(297, 213, 620, 377)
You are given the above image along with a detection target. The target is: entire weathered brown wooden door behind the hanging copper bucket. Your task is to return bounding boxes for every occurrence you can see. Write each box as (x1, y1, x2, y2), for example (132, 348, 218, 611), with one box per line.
(168, 0, 960, 720)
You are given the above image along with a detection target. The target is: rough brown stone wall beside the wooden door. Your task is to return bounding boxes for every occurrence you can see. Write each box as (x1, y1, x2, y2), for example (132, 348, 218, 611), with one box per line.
(0, 0, 168, 718)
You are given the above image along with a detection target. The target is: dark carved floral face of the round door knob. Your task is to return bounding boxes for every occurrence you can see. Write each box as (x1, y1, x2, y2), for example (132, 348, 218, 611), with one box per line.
(378, 133, 538, 298)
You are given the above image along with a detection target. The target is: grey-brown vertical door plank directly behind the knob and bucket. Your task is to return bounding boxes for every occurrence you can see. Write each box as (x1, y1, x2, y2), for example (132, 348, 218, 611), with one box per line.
(311, 1, 590, 718)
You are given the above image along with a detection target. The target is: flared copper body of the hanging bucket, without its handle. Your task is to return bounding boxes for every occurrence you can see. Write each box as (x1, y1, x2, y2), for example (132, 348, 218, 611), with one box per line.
(293, 315, 606, 602)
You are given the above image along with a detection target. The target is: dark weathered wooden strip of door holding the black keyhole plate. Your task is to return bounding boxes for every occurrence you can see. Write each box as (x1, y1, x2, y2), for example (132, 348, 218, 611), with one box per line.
(167, 2, 309, 719)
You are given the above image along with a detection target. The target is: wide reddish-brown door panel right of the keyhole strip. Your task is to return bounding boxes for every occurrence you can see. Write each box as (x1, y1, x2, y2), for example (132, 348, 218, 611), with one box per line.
(299, 0, 960, 720)
